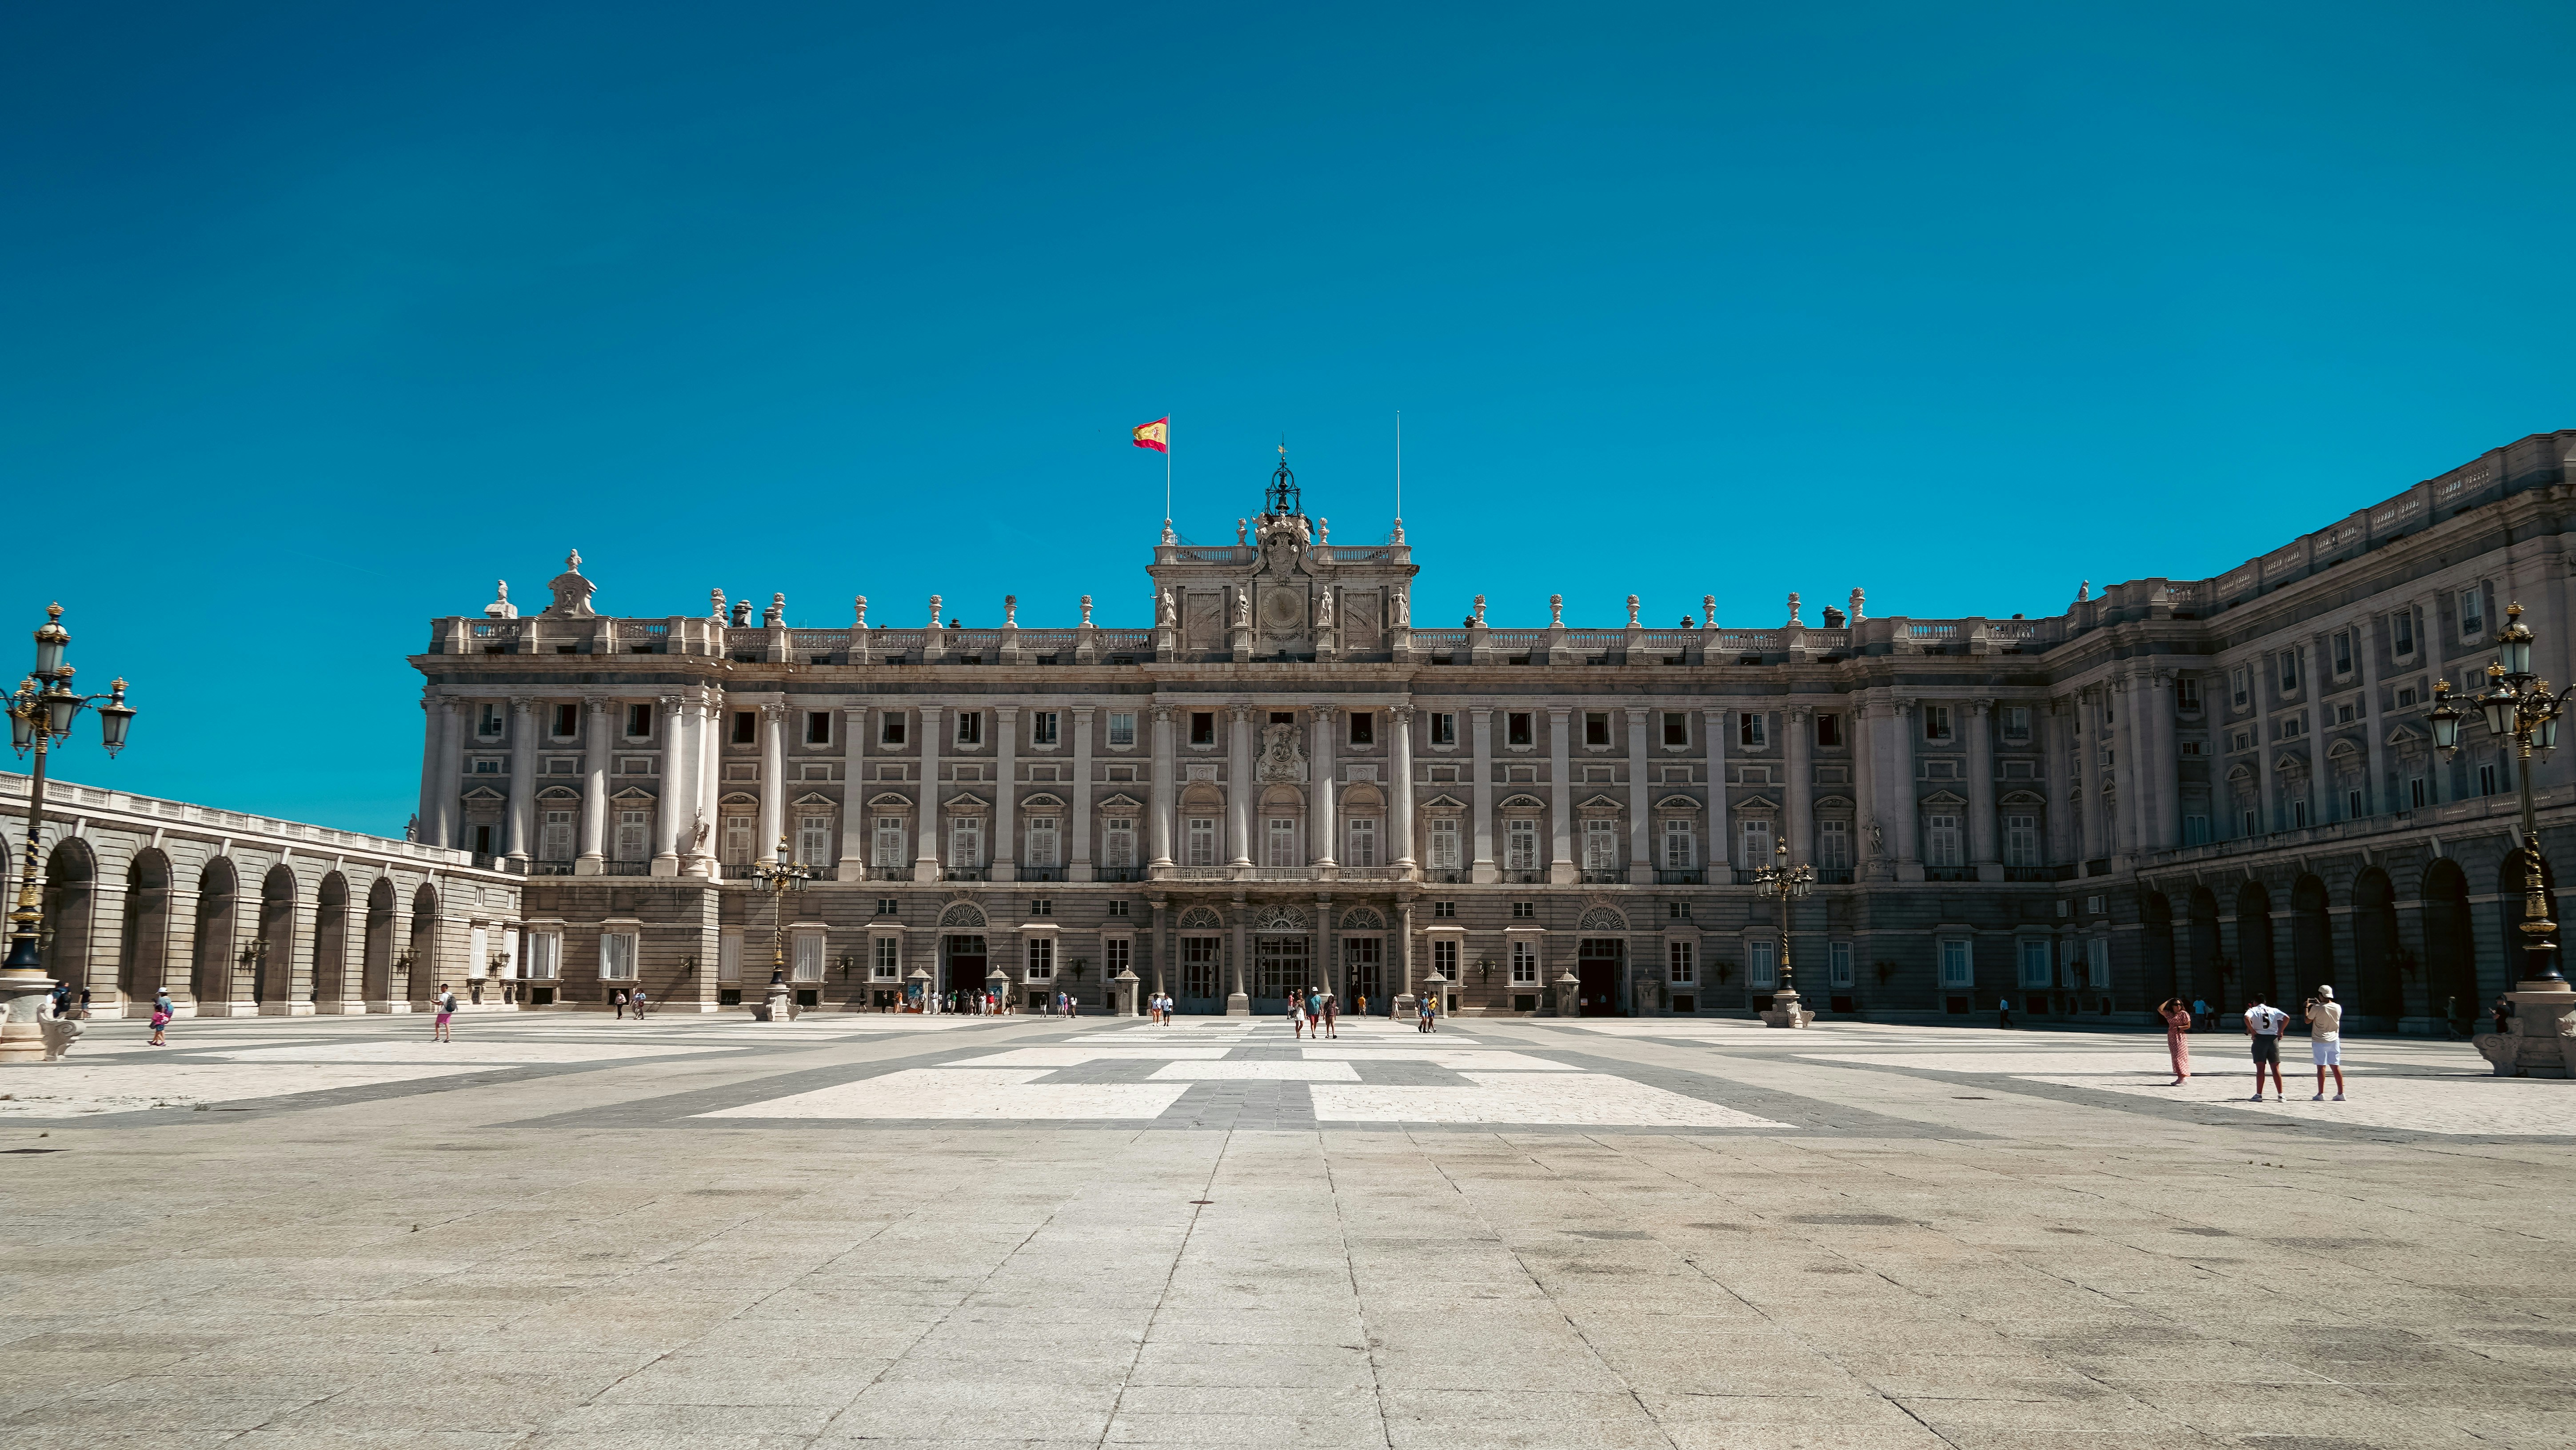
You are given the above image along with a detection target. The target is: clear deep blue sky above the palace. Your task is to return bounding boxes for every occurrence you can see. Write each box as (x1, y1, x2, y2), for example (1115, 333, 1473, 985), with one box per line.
(0, 3, 2576, 832)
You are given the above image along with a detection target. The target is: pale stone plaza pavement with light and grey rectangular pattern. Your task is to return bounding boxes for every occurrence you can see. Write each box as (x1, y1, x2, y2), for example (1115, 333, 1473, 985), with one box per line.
(0, 1012, 2576, 1450)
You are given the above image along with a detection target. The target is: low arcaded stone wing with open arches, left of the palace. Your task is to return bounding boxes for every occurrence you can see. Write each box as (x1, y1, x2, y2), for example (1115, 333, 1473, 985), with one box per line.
(0, 775, 528, 1017)
